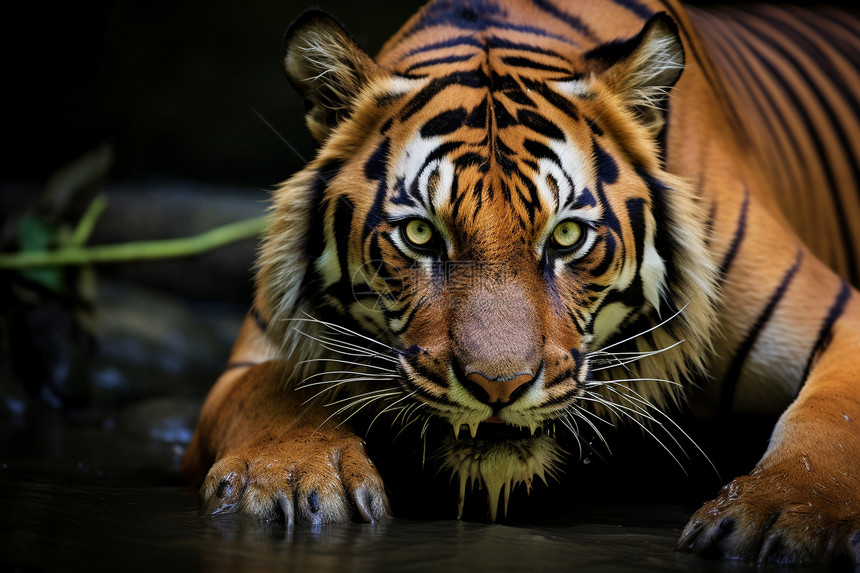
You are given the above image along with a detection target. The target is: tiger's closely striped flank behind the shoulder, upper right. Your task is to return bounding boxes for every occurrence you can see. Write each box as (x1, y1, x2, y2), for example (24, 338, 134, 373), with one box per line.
(688, 5, 860, 286)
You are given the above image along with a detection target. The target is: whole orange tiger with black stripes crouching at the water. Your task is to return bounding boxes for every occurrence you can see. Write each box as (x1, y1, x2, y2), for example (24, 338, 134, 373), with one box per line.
(181, 0, 860, 564)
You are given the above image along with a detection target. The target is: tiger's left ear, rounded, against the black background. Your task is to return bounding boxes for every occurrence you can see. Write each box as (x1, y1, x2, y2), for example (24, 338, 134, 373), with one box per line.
(284, 9, 377, 143)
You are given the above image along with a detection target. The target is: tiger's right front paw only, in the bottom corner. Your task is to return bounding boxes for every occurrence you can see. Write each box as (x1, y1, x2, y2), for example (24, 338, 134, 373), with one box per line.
(676, 468, 860, 565)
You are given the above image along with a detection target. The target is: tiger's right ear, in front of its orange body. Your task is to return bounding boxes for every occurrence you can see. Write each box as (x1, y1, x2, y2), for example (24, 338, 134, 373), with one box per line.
(585, 12, 684, 135)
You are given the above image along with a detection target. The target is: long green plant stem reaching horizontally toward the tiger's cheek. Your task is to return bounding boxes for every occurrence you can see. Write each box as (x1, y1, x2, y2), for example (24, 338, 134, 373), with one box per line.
(0, 217, 267, 269)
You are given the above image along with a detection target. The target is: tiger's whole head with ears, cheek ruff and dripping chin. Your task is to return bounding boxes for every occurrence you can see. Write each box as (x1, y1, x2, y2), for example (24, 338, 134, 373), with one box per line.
(258, 6, 716, 518)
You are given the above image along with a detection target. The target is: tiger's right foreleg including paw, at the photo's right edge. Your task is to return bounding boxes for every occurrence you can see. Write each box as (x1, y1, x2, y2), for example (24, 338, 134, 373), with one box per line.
(678, 303, 860, 565)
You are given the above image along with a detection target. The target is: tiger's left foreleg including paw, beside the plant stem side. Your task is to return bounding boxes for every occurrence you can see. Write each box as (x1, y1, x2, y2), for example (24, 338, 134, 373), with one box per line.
(182, 361, 389, 525)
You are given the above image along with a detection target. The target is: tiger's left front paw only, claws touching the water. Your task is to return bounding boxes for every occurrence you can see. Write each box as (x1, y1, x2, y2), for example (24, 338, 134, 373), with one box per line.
(200, 431, 390, 525)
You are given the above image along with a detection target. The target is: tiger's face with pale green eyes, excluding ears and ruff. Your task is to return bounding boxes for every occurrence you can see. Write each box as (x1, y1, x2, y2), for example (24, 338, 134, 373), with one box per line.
(366, 97, 665, 420)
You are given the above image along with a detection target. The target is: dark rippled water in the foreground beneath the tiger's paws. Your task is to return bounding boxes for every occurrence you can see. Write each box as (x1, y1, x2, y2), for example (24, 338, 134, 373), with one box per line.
(0, 469, 836, 573)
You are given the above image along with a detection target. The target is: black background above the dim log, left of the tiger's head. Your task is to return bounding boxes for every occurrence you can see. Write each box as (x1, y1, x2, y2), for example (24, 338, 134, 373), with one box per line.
(0, 0, 420, 188)
